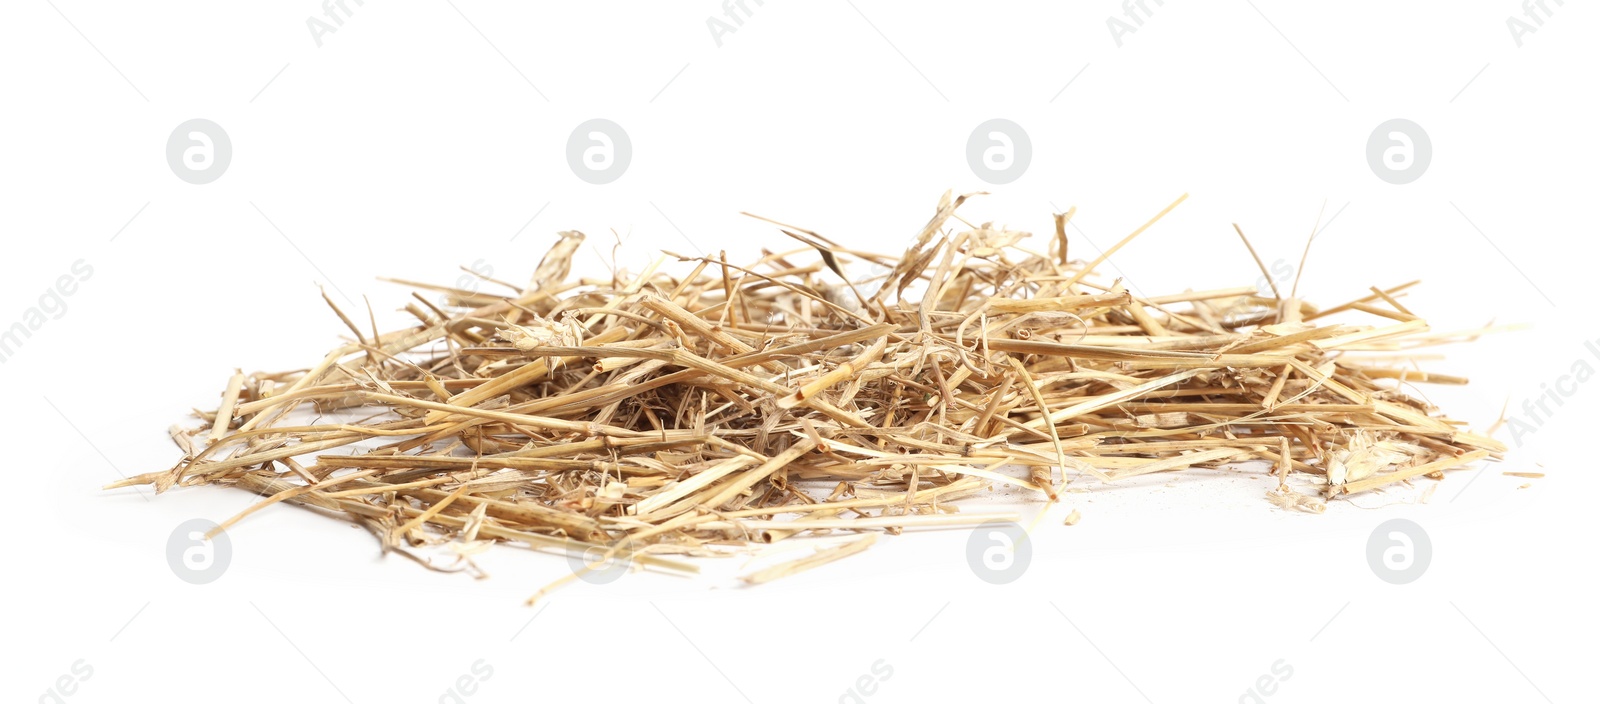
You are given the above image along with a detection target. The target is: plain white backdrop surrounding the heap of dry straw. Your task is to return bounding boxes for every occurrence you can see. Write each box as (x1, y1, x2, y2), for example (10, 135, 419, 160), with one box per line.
(0, 0, 1600, 704)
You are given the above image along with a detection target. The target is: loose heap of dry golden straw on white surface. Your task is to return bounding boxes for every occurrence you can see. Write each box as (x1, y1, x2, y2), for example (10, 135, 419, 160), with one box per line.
(112, 195, 1506, 595)
